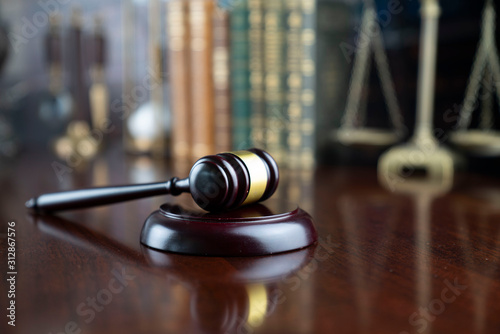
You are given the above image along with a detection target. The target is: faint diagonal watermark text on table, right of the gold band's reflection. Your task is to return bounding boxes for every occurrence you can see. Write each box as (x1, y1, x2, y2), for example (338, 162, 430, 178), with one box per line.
(230, 235, 338, 334)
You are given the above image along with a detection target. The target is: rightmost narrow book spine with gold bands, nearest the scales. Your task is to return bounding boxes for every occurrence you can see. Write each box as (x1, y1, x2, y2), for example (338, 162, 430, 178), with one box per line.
(300, 0, 317, 170)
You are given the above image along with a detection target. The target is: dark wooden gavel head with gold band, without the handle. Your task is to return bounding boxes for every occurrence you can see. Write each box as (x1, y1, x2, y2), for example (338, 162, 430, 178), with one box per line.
(189, 148, 279, 211)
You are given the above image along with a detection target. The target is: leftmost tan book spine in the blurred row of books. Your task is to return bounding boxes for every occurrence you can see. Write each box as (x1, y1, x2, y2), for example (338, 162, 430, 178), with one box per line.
(166, 0, 192, 160)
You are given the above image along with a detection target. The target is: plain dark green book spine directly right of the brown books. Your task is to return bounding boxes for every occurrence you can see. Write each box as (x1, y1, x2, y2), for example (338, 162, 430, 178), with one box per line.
(231, 0, 252, 149)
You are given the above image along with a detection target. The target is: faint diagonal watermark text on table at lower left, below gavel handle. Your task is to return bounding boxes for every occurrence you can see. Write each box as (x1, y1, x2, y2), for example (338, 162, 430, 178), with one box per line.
(49, 264, 136, 334)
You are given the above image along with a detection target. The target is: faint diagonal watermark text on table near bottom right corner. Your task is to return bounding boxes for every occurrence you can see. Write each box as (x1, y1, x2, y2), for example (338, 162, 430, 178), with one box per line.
(399, 278, 467, 334)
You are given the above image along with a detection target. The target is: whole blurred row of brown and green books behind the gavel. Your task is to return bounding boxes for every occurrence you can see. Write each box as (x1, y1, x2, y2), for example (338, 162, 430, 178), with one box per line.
(167, 0, 316, 169)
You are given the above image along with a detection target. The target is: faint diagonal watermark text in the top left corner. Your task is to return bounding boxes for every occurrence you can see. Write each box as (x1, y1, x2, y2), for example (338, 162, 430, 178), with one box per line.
(7, 0, 73, 53)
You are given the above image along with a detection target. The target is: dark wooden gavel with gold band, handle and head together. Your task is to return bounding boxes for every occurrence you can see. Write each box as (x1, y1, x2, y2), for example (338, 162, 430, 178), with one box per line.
(26, 148, 279, 213)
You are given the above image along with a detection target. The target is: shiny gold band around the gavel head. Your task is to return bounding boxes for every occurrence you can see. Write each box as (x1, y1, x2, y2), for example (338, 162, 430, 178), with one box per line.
(230, 151, 269, 205)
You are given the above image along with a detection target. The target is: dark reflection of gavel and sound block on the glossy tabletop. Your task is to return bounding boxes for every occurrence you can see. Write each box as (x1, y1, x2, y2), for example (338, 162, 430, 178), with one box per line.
(30, 213, 316, 333)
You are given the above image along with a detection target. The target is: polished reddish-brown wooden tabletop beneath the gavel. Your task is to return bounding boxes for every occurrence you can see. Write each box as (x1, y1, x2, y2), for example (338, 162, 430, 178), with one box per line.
(0, 150, 500, 334)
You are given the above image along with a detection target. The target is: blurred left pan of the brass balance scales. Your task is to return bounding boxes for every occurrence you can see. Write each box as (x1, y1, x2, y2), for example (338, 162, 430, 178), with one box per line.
(333, 128, 401, 147)
